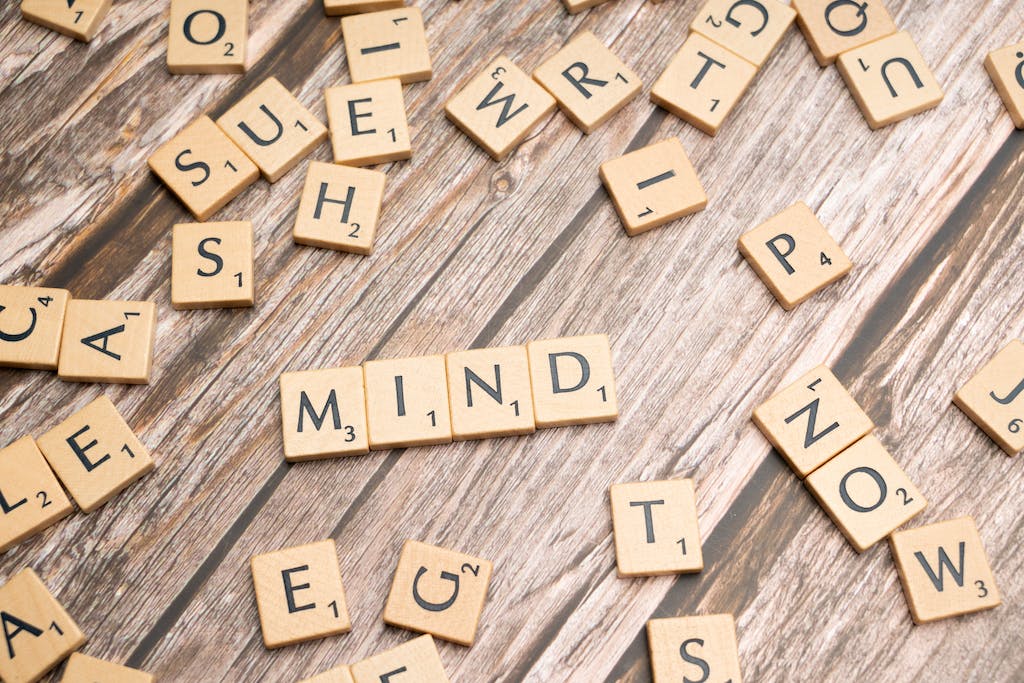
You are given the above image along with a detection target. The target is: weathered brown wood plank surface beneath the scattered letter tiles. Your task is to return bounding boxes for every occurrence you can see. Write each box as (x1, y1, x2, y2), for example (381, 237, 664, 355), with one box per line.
(0, 0, 1024, 683)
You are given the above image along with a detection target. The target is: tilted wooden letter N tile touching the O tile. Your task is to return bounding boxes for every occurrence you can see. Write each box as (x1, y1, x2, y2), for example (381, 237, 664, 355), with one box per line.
(754, 366, 874, 478)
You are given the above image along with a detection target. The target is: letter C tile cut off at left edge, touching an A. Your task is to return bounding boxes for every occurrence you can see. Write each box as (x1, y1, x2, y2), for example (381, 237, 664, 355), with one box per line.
(0, 285, 71, 370)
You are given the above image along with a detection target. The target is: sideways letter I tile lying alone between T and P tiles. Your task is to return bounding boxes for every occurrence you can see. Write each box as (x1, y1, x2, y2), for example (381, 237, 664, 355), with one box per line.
(600, 137, 708, 237)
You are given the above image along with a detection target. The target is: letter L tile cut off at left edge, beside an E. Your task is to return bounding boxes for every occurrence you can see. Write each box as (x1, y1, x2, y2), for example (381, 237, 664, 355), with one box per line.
(0, 436, 73, 553)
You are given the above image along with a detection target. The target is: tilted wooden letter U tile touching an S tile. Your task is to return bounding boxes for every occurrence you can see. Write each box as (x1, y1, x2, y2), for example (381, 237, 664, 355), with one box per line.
(217, 78, 327, 182)
